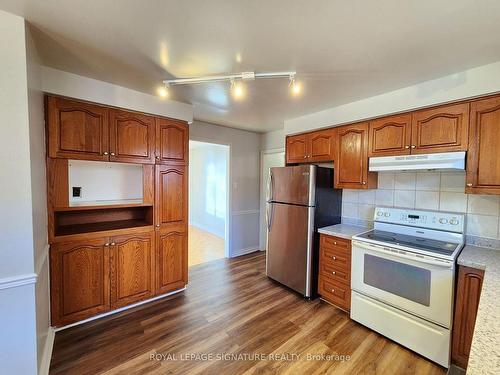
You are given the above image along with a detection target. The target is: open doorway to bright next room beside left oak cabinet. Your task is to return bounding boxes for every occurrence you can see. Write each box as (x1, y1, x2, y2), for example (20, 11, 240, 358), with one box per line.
(188, 141, 229, 267)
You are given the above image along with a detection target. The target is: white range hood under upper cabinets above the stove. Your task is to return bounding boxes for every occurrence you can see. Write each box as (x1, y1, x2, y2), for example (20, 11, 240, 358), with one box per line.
(369, 151, 465, 172)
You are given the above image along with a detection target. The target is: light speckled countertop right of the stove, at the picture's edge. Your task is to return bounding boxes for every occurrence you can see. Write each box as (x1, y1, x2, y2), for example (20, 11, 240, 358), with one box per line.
(458, 246, 500, 375)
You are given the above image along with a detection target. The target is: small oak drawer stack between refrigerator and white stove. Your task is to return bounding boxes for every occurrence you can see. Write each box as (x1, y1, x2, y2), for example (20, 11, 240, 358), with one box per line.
(318, 234, 351, 311)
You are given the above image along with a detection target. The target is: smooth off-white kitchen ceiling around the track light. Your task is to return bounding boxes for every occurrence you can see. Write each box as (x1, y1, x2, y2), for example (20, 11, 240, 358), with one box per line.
(0, 0, 500, 132)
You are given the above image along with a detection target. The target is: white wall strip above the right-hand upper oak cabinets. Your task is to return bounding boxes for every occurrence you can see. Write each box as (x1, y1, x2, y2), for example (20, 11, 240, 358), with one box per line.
(284, 62, 500, 134)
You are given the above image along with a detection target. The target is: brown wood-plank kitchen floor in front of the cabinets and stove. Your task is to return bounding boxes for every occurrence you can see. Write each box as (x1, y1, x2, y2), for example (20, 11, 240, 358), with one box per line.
(50, 253, 445, 375)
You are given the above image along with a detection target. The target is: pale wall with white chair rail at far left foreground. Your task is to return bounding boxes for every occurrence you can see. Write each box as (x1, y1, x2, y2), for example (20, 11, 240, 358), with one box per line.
(0, 11, 38, 374)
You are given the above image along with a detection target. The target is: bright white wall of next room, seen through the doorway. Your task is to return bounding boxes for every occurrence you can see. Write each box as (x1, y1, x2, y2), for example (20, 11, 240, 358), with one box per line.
(189, 141, 229, 238)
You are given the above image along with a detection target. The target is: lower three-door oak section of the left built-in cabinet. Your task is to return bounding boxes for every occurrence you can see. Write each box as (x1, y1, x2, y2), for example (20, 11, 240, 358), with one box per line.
(50, 225, 188, 327)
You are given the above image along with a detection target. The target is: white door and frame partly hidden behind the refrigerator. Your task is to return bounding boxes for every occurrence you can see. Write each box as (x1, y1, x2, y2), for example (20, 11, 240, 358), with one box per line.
(259, 149, 285, 251)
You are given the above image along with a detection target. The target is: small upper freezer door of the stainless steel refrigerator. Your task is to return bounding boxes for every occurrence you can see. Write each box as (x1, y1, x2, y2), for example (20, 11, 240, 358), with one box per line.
(268, 165, 316, 206)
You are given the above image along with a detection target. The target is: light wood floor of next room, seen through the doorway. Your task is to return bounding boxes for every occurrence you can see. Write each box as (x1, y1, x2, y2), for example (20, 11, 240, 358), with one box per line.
(188, 225, 224, 267)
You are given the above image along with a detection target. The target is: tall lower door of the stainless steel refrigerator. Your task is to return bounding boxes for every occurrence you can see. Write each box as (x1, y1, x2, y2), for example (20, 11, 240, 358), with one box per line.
(266, 203, 314, 297)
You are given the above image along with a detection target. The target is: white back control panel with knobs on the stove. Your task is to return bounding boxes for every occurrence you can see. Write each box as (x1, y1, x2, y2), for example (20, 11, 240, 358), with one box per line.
(374, 207, 464, 233)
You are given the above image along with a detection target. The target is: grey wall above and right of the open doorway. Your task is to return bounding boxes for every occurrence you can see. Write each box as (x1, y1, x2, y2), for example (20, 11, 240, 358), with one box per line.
(189, 120, 261, 256)
